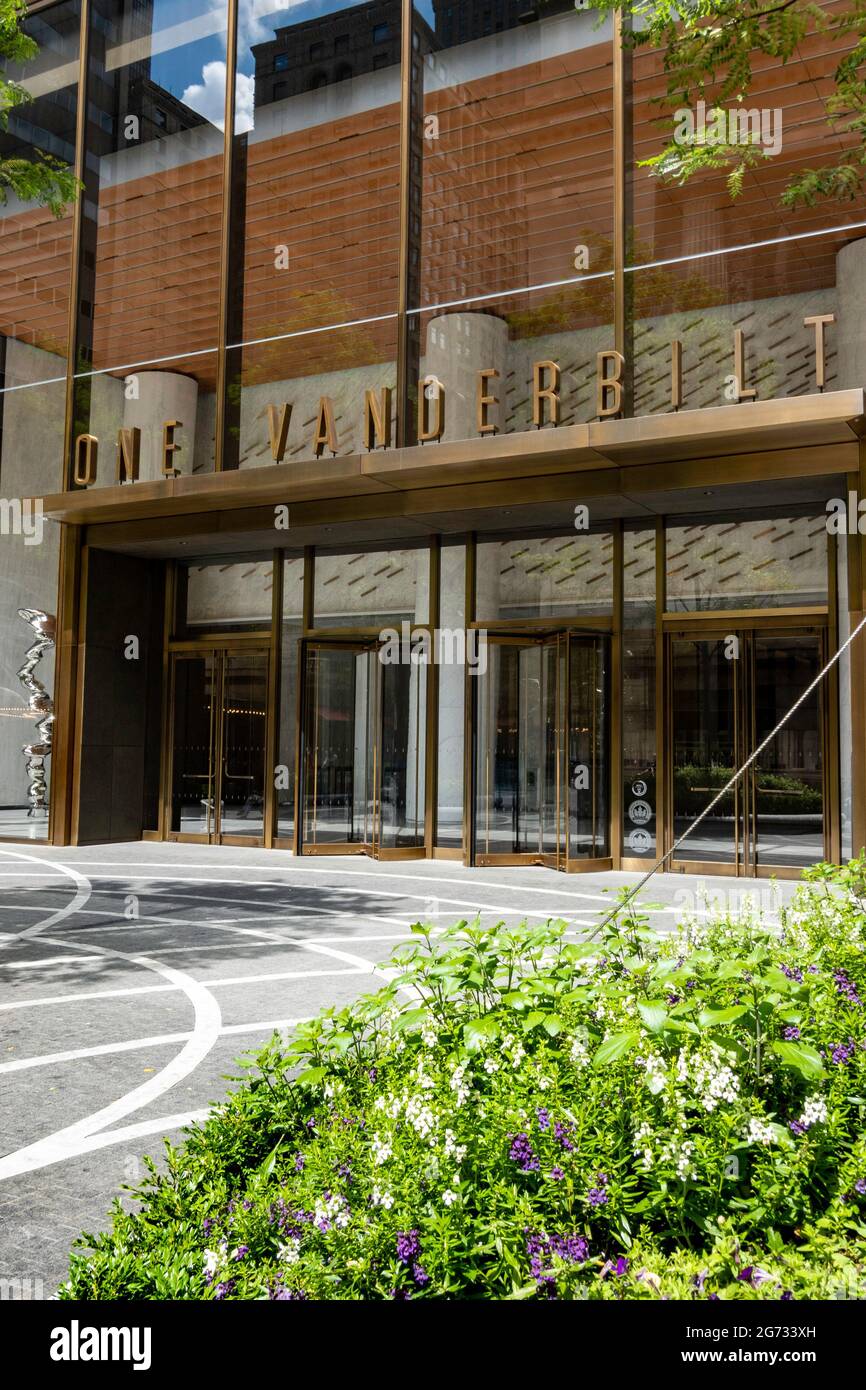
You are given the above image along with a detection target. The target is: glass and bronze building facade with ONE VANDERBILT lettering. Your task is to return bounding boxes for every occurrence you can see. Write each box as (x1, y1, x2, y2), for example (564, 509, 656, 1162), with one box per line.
(0, 0, 866, 876)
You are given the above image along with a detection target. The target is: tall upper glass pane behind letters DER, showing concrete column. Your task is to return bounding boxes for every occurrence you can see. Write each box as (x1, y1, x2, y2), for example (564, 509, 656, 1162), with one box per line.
(407, 0, 613, 442)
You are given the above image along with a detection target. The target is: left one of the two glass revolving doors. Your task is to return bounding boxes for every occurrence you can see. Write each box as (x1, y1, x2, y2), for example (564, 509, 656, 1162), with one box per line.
(302, 642, 427, 858)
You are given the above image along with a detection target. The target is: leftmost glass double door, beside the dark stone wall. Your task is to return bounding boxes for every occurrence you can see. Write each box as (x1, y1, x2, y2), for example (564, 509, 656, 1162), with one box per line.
(168, 649, 268, 845)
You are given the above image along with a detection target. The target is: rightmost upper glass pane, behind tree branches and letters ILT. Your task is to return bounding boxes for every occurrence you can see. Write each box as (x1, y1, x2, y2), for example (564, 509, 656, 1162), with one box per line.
(628, 6, 866, 414)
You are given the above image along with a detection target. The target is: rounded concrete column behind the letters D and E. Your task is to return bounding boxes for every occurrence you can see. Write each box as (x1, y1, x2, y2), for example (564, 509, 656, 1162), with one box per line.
(421, 314, 509, 439)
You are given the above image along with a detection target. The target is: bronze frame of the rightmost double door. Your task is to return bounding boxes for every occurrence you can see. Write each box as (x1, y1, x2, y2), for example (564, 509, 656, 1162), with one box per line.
(657, 622, 838, 878)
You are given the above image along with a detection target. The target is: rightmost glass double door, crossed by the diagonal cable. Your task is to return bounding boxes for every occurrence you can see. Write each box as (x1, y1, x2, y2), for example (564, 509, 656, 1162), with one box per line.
(667, 626, 827, 874)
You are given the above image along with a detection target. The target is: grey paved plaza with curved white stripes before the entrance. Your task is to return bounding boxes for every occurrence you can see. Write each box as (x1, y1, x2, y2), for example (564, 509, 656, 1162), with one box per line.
(0, 844, 794, 1297)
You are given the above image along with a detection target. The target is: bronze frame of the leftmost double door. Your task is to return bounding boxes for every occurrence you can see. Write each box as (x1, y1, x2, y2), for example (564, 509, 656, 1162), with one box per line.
(161, 635, 269, 848)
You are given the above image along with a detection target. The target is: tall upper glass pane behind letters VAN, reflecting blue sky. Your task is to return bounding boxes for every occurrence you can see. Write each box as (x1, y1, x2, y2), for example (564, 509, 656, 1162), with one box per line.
(224, 0, 400, 468)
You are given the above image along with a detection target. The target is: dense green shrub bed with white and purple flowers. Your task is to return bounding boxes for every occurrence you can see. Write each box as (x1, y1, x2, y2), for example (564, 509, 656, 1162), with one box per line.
(61, 859, 866, 1298)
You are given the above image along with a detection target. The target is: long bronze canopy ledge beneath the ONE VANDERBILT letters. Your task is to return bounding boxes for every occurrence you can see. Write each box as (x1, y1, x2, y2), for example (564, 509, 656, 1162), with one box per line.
(43, 388, 866, 524)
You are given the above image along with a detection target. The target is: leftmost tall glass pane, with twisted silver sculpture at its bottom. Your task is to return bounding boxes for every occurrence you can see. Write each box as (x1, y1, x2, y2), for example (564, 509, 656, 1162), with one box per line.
(0, 0, 81, 840)
